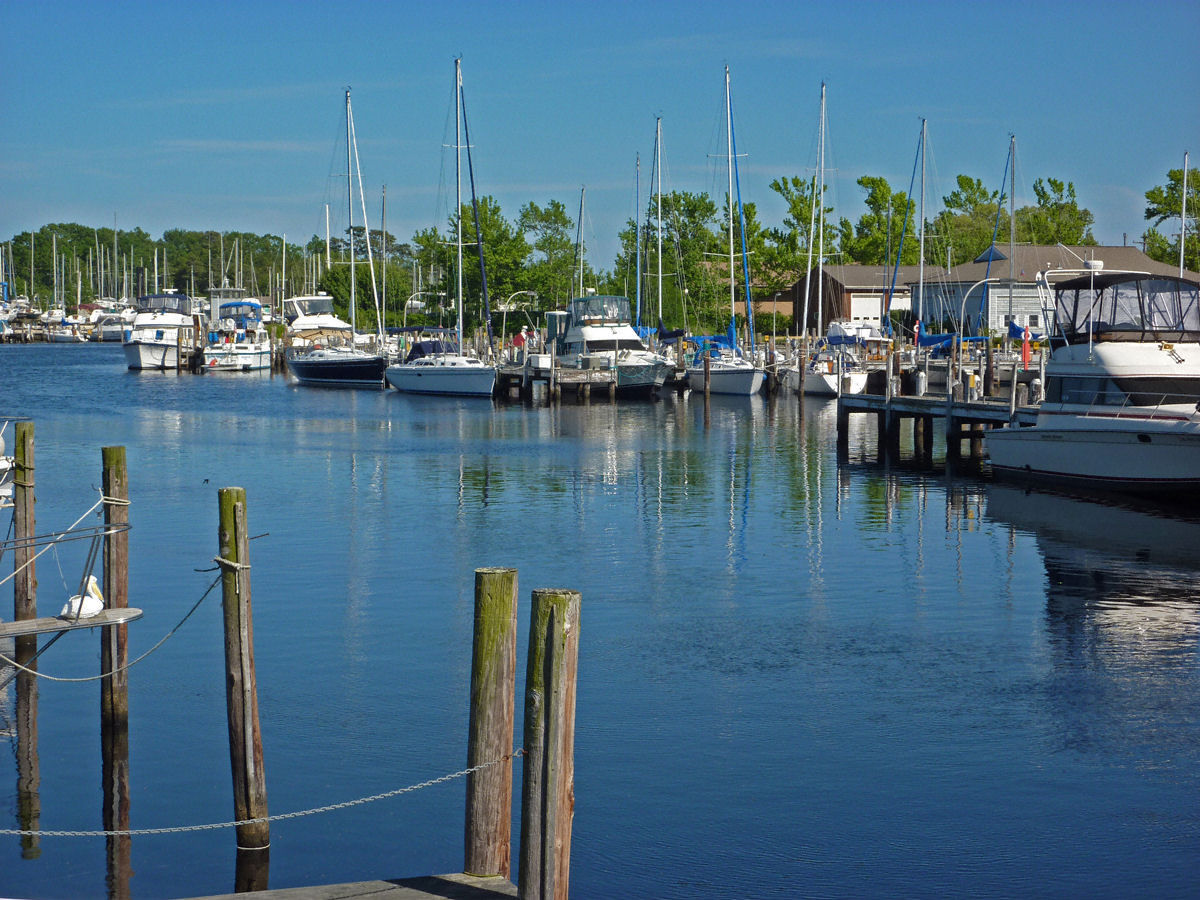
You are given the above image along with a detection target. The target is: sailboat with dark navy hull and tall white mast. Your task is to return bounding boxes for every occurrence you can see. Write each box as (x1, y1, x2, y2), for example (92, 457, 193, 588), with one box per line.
(288, 90, 388, 388)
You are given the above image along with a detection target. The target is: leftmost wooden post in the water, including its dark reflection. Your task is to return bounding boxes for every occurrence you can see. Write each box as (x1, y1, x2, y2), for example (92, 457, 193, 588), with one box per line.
(12, 422, 42, 859)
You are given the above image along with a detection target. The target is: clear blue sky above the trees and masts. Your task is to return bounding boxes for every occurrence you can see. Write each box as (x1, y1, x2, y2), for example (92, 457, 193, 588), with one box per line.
(0, 0, 1200, 268)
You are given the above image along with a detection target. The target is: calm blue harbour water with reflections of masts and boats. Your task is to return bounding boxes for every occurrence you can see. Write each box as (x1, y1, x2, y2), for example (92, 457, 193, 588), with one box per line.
(0, 346, 1200, 898)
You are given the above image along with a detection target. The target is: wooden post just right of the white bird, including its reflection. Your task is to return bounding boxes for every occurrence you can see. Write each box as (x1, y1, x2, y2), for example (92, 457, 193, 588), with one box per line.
(100, 446, 132, 896)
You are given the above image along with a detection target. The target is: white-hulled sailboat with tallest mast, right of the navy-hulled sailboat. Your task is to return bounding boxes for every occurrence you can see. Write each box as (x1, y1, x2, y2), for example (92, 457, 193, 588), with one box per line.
(384, 59, 496, 397)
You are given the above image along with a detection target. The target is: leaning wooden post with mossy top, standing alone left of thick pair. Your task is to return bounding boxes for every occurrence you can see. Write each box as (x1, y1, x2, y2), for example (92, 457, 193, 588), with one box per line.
(217, 487, 271, 873)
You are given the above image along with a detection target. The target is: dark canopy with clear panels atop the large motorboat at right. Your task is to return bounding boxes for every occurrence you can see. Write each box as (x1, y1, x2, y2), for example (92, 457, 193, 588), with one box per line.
(1052, 271, 1200, 343)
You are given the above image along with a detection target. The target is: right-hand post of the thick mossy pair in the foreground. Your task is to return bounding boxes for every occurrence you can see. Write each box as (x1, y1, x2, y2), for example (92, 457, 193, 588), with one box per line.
(517, 589, 581, 900)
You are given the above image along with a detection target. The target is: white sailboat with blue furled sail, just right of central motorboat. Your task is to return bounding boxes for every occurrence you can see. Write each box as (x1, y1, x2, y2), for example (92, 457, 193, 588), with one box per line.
(688, 66, 764, 396)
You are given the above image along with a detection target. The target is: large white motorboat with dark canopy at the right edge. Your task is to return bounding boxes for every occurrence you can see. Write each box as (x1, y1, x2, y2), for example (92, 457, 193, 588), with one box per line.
(984, 266, 1200, 493)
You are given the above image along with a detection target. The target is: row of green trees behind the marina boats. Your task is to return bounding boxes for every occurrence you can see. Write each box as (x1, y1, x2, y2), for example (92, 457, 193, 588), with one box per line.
(2, 169, 1200, 331)
